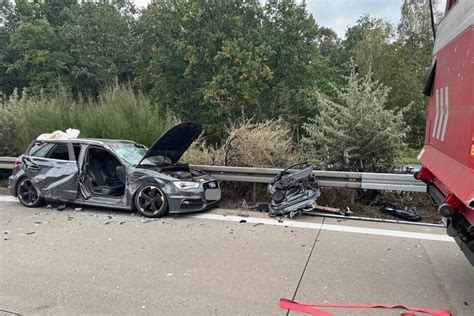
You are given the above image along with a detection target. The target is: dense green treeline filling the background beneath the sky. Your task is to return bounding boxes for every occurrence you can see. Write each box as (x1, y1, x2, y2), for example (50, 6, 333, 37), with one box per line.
(0, 0, 439, 165)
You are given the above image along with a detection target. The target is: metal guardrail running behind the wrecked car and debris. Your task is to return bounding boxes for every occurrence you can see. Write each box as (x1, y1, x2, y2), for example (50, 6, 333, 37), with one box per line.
(0, 157, 426, 192)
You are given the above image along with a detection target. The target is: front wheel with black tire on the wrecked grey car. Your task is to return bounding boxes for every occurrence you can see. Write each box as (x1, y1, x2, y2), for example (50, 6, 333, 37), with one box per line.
(133, 184, 168, 217)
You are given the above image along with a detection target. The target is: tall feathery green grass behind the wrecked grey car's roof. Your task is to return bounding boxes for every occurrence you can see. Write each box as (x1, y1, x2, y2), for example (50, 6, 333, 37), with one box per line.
(0, 86, 176, 156)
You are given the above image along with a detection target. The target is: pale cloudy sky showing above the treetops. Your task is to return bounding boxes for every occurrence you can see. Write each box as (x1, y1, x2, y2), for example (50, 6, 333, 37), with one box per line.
(134, 0, 446, 37)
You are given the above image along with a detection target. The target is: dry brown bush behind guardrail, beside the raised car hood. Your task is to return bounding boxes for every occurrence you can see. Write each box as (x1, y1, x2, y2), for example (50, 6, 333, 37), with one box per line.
(183, 120, 292, 168)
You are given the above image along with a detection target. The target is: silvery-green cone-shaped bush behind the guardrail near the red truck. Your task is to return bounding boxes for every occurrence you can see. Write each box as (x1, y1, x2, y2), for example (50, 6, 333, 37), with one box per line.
(302, 70, 409, 171)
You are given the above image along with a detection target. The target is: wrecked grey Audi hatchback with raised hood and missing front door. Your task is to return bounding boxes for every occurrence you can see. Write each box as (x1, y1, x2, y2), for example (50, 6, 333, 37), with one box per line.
(8, 122, 221, 217)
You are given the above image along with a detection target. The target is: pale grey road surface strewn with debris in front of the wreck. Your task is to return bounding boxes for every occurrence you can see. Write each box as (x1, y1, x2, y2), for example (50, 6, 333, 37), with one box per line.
(0, 198, 474, 316)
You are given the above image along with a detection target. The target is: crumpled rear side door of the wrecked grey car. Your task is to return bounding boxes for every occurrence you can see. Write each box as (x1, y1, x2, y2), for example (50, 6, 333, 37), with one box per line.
(22, 143, 78, 200)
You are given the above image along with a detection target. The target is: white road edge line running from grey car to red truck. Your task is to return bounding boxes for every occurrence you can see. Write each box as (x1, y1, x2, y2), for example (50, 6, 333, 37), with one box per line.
(189, 213, 454, 242)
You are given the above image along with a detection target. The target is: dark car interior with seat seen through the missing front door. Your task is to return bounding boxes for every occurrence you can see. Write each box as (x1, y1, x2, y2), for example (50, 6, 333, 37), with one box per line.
(84, 147, 125, 196)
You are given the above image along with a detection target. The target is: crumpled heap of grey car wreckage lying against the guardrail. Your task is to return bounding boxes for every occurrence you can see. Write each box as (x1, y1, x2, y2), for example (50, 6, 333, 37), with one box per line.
(268, 163, 321, 217)
